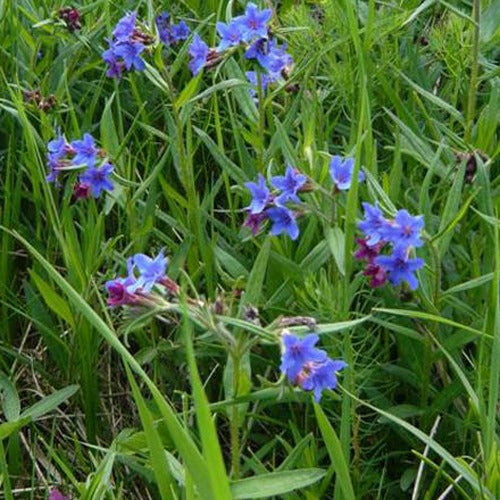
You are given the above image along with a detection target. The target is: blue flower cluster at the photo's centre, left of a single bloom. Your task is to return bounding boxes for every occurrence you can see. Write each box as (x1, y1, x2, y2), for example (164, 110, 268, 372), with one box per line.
(244, 166, 307, 240)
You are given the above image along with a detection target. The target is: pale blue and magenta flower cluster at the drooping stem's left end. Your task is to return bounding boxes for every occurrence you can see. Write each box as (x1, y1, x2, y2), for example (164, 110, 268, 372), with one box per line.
(105, 251, 178, 307)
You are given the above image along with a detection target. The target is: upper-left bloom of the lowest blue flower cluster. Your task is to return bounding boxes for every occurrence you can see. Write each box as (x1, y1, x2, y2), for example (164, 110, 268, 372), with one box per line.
(280, 333, 327, 382)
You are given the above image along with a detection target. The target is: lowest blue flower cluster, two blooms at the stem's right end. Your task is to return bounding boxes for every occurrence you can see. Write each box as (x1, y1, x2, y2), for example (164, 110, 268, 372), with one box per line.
(280, 332, 347, 402)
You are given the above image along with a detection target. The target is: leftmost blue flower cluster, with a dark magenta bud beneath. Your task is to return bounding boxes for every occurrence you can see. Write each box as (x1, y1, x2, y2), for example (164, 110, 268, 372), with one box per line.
(46, 134, 113, 198)
